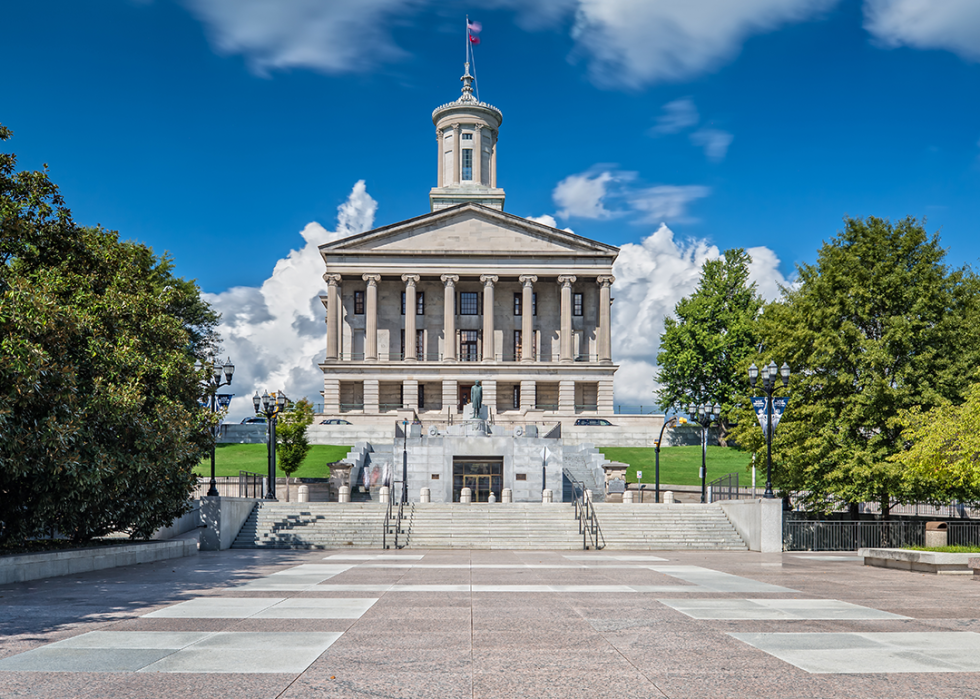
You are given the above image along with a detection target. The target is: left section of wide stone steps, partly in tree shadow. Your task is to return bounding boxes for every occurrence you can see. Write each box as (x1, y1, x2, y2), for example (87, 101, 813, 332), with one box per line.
(232, 502, 387, 549)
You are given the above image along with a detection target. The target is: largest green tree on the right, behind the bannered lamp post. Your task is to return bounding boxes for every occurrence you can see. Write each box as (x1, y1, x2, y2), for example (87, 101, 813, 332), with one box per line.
(735, 217, 980, 513)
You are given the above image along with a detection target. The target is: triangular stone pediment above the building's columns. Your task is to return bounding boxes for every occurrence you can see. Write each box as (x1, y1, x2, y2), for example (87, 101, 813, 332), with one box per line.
(320, 203, 619, 256)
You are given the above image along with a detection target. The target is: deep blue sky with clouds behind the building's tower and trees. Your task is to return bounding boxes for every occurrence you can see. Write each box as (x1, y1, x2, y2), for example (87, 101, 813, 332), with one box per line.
(0, 0, 980, 412)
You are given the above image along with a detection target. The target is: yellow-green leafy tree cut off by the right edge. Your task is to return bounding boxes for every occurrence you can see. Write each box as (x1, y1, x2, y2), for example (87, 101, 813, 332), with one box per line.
(891, 386, 980, 503)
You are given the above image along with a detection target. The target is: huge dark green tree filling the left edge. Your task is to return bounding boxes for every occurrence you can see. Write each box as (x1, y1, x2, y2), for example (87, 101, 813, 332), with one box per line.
(0, 124, 218, 541)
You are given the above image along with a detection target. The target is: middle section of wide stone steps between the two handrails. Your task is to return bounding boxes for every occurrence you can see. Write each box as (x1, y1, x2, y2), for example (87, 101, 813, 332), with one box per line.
(398, 503, 582, 550)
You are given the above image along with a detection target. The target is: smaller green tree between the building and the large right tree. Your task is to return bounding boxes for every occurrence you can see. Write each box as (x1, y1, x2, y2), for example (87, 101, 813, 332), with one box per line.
(657, 248, 762, 446)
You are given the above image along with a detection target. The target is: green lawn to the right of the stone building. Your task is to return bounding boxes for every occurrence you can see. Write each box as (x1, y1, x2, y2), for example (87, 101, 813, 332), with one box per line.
(599, 446, 752, 486)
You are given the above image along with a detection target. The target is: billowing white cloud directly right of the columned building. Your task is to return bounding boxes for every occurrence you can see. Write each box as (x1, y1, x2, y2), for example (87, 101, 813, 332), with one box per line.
(612, 225, 786, 406)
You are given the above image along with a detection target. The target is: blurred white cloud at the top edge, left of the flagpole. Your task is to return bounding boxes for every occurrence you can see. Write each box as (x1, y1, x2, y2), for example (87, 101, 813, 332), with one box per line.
(186, 0, 424, 75)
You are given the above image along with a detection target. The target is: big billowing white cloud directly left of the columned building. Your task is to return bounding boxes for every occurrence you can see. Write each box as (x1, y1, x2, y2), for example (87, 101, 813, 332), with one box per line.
(204, 180, 378, 420)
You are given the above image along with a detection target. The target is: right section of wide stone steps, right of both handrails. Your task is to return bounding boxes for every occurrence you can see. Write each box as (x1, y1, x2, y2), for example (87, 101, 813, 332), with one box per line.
(595, 503, 748, 551)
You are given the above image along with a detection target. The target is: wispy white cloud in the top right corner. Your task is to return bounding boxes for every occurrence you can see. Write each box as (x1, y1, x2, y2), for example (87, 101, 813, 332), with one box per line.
(864, 0, 980, 61)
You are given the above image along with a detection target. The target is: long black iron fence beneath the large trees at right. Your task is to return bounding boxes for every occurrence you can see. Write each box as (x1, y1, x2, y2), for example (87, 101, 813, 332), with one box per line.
(783, 519, 980, 551)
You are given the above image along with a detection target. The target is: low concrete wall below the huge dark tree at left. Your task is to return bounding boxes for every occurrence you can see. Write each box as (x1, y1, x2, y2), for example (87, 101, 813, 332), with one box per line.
(0, 538, 197, 585)
